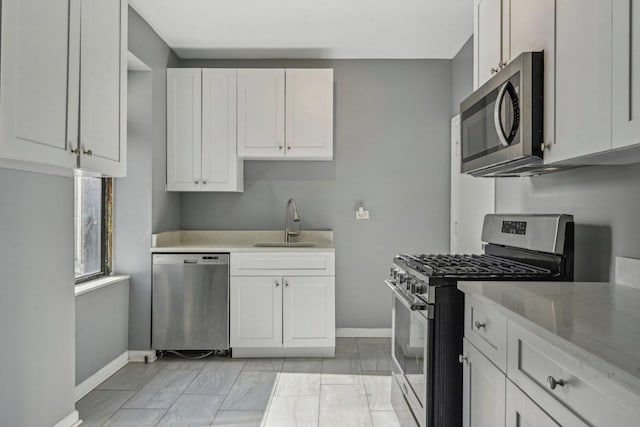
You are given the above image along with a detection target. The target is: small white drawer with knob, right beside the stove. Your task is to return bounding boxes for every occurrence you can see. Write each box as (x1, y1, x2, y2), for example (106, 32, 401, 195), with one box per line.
(464, 295, 507, 372)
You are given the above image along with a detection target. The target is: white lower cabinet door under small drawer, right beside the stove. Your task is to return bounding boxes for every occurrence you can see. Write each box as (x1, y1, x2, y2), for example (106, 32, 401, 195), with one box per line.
(462, 338, 506, 427)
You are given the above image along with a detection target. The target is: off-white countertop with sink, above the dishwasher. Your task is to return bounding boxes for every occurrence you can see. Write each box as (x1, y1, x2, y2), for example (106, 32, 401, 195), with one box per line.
(151, 230, 335, 253)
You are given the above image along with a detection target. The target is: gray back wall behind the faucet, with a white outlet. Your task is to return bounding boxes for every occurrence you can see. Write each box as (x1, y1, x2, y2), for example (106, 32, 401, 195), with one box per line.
(181, 60, 451, 328)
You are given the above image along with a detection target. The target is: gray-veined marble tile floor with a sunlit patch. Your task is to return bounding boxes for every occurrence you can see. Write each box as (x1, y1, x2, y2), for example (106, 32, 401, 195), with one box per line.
(76, 338, 399, 427)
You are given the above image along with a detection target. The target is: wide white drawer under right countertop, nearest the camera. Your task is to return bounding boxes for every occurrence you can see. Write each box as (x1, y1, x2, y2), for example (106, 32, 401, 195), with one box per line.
(507, 322, 640, 426)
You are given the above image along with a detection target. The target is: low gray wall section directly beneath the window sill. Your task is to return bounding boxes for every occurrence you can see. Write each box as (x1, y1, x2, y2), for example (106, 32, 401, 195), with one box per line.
(76, 280, 129, 385)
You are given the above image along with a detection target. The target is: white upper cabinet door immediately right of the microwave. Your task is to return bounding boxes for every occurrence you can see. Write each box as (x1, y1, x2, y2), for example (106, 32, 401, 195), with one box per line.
(544, 0, 612, 163)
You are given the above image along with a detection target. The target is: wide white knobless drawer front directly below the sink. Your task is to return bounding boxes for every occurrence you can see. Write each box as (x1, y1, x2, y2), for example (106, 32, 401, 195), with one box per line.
(230, 252, 335, 276)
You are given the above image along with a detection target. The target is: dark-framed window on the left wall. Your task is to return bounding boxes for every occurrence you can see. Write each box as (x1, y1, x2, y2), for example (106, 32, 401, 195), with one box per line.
(74, 176, 112, 283)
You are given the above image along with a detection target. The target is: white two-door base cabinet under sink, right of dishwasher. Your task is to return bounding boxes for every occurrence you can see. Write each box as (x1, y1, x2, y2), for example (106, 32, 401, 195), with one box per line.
(229, 251, 336, 357)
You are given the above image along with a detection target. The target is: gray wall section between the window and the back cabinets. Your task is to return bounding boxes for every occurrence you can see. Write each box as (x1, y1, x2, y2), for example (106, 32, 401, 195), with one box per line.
(124, 8, 180, 350)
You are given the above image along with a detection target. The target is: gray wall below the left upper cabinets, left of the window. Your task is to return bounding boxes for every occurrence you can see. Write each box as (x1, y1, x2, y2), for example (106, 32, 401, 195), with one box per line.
(0, 169, 75, 426)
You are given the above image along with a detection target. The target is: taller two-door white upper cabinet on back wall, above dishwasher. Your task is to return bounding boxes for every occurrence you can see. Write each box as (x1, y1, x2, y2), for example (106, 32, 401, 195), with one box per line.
(167, 68, 244, 191)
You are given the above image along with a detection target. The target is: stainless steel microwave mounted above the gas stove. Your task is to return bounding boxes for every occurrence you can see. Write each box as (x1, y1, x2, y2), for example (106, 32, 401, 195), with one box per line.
(460, 52, 544, 177)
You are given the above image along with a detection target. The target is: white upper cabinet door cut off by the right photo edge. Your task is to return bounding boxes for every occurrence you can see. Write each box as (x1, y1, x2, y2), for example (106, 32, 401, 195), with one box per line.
(612, 0, 640, 148)
